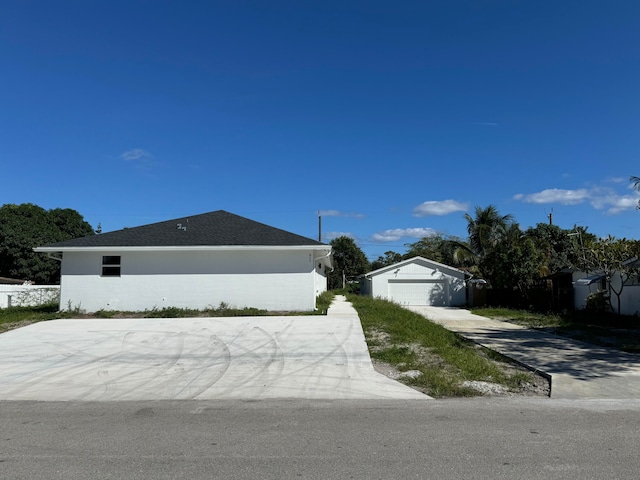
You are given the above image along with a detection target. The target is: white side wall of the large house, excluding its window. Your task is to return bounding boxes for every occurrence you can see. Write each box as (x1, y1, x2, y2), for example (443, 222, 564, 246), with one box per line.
(60, 250, 326, 312)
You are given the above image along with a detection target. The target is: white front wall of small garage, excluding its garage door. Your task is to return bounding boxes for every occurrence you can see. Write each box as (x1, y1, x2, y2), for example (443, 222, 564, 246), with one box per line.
(361, 259, 467, 306)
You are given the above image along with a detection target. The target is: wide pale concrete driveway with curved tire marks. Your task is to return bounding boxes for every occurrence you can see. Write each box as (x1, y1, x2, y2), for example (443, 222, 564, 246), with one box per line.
(0, 297, 429, 401)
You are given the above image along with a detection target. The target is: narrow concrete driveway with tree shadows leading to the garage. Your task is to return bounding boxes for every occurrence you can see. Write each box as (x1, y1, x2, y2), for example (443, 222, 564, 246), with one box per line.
(407, 306, 640, 399)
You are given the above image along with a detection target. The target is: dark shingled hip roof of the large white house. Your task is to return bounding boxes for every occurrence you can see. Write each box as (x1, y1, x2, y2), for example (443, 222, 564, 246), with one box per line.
(44, 210, 324, 248)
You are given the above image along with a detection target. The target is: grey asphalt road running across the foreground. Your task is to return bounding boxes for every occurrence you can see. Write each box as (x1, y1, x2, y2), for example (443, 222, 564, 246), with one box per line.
(0, 398, 640, 480)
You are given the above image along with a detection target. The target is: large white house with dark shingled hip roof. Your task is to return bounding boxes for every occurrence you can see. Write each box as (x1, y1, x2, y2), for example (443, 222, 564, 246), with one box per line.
(34, 210, 332, 312)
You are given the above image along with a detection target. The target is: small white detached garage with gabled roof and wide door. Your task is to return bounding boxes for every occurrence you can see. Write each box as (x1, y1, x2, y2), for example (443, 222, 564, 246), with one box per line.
(360, 257, 468, 307)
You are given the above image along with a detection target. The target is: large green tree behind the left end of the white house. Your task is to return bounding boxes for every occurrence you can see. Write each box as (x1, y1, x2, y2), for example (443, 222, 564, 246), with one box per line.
(0, 203, 94, 284)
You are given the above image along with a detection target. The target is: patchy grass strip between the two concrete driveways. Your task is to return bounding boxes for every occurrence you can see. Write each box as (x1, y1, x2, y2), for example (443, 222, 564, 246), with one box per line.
(347, 295, 532, 398)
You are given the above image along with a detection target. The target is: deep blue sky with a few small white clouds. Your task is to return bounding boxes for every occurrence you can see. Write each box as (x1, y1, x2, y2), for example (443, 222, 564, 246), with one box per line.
(0, 0, 640, 259)
